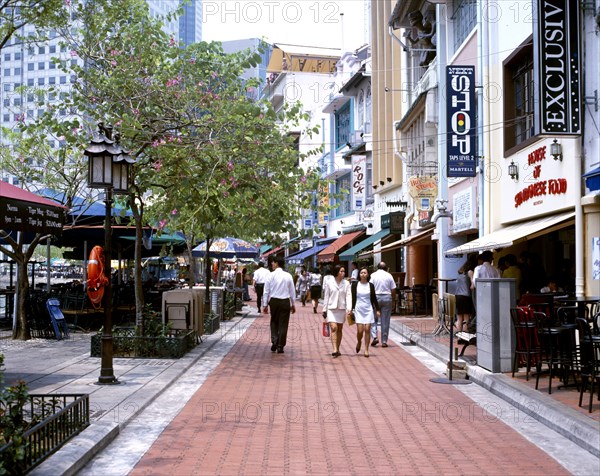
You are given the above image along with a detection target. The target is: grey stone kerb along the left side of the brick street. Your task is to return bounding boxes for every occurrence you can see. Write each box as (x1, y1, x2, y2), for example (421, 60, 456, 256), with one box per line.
(28, 312, 249, 476)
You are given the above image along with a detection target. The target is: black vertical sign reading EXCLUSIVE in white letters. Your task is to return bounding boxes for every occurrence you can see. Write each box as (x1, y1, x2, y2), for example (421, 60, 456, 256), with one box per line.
(533, 0, 581, 135)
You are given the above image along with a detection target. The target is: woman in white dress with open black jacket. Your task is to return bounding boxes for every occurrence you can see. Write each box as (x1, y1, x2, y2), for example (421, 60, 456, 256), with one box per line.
(346, 268, 381, 357)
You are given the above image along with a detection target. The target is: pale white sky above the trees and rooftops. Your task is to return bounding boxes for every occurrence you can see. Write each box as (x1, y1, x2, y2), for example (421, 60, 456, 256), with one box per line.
(202, 0, 368, 51)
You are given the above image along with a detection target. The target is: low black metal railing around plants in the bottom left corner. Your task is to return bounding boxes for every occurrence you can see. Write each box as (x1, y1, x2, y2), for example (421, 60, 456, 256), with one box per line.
(0, 394, 90, 472)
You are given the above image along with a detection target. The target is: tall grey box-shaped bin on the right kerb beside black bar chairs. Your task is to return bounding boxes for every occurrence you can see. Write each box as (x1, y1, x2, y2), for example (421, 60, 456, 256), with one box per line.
(476, 278, 516, 373)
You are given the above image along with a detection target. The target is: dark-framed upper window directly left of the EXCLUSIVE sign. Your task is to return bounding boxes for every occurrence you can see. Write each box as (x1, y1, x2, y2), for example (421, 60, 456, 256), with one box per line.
(503, 37, 535, 155)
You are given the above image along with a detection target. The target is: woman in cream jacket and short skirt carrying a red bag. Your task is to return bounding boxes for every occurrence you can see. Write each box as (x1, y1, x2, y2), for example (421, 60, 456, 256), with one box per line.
(324, 264, 350, 358)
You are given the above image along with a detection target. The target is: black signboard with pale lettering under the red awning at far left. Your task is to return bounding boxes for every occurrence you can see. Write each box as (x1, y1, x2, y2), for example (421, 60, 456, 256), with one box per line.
(0, 197, 65, 235)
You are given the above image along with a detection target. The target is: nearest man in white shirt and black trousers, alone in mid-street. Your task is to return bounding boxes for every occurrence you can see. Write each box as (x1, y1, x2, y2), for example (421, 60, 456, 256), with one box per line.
(263, 256, 296, 354)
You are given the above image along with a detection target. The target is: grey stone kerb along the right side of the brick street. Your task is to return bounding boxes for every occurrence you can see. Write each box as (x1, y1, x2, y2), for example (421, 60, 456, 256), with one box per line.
(390, 320, 600, 457)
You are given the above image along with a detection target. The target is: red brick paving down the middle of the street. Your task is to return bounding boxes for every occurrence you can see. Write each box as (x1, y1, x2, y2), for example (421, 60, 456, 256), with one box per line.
(131, 306, 568, 475)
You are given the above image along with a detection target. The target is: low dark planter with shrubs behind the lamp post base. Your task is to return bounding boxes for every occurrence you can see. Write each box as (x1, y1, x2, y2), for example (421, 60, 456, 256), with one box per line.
(91, 328, 198, 359)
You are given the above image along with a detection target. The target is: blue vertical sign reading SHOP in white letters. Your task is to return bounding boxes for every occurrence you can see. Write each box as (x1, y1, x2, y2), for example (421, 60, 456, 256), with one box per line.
(446, 66, 477, 177)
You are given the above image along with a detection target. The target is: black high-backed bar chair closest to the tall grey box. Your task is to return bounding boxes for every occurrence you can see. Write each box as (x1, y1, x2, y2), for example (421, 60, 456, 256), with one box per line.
(510, 307, 540, 382)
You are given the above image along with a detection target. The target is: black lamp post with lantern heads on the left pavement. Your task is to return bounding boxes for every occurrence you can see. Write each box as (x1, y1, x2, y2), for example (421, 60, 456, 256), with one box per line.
(84, 123, 134, 385)
